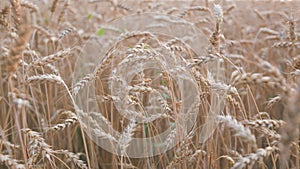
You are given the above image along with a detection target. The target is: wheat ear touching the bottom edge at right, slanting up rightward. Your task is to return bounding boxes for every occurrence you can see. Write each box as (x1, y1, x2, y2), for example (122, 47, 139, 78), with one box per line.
(231, 147, 278, 169)
